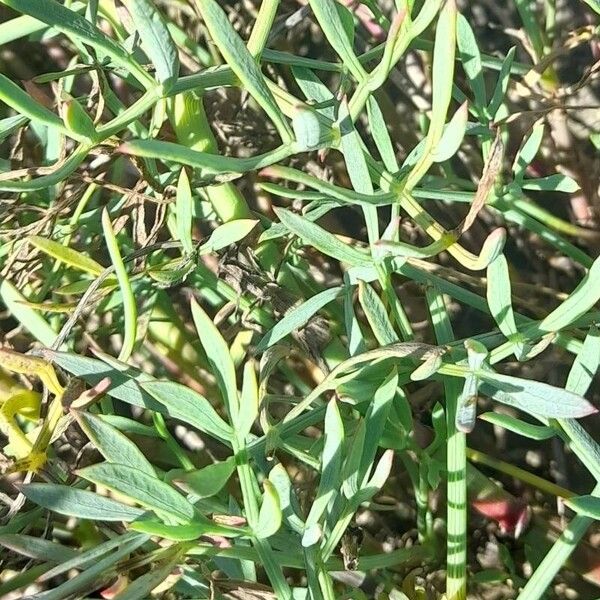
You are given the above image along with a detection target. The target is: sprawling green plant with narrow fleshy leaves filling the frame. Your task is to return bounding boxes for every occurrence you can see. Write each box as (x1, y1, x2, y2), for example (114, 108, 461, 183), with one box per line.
(0, 0, 600, 600)
